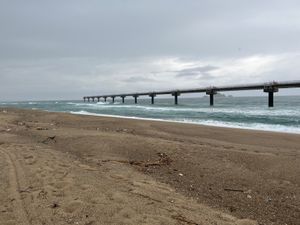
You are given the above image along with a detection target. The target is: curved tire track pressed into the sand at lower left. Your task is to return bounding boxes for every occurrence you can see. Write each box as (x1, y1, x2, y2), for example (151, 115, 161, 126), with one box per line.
(0, 148, 31, 225)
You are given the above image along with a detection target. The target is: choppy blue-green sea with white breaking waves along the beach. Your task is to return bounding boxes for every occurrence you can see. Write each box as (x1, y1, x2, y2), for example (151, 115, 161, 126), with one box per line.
(0, 96, 300, 133)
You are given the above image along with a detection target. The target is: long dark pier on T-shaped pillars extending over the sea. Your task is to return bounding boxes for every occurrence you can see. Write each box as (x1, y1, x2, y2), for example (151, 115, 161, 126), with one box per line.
(83, 81, 300, 107)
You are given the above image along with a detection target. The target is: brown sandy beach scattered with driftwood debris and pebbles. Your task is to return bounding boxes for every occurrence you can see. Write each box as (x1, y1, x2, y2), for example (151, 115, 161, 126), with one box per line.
(0, 108, 300, 225)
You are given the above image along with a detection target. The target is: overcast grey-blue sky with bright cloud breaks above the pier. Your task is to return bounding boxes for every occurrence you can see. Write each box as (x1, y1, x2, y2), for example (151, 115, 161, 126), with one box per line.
(0, 0, 300, 100)
